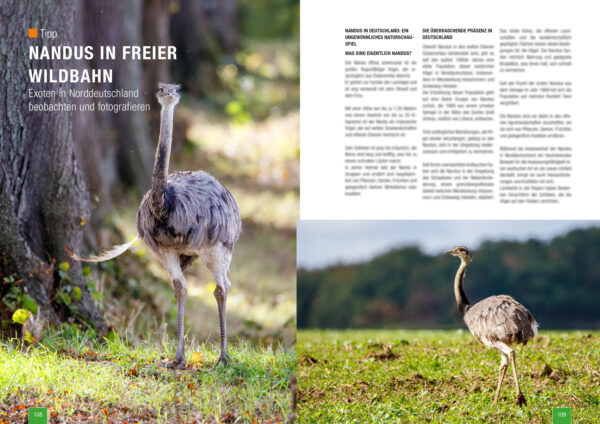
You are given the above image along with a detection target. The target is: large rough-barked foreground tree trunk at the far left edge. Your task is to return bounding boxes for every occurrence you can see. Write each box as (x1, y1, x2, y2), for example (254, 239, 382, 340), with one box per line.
(0, 0, 107, 334)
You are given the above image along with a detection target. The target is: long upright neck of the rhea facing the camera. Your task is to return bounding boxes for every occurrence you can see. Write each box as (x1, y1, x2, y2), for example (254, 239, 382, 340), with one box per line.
(151, 105, 175, 209)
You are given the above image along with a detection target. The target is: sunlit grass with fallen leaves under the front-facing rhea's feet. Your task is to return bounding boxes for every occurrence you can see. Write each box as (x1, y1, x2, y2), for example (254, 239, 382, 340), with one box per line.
(0, 326, 295, 423)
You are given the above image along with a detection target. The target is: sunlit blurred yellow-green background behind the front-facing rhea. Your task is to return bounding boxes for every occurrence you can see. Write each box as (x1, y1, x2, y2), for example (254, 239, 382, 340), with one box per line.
(112, 0, 299, 346)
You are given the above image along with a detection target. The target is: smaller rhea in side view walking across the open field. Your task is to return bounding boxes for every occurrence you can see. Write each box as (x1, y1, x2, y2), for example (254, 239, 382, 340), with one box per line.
(446, 246, 538, 406)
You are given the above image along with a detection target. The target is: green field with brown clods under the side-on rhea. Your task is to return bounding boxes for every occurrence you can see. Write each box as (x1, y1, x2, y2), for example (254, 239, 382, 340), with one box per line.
(297, 330, 600, 423)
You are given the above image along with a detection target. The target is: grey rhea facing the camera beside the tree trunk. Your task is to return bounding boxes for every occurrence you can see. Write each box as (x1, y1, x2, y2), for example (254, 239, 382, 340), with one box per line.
(71, 83, 242, 368)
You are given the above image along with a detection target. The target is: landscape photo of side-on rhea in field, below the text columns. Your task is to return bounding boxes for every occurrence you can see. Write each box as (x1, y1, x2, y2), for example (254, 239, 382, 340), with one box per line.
(297, 221, 600, 423)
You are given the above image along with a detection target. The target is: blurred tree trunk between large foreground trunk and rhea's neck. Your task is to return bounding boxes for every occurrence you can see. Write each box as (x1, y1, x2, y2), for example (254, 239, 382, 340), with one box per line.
(74, 0, 154, 200)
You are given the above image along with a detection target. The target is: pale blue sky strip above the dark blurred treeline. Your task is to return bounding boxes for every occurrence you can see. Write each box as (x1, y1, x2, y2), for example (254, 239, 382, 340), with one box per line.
(297, 221, 600, 269)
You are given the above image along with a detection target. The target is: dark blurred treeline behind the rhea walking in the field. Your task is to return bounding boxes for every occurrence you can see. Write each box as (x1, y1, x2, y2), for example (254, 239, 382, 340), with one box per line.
(298, 228, 600, 329)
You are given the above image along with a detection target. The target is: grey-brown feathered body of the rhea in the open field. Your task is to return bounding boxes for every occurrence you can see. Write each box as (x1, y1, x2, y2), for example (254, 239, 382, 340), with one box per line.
(465, 295, 538, 343)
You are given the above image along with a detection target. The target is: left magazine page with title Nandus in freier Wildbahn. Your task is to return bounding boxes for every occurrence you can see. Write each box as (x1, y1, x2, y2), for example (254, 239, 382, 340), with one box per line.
(0, 0, 299, 423)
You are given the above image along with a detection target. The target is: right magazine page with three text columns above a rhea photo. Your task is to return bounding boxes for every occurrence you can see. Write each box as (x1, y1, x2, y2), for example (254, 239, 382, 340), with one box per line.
(297, 0, 600, 424)
